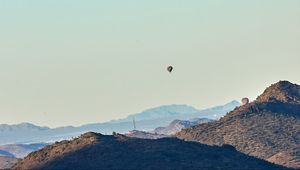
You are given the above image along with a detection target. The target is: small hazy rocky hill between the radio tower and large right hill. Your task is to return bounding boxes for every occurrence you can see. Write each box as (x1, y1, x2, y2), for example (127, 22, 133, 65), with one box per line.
(153, 118, 213, 135)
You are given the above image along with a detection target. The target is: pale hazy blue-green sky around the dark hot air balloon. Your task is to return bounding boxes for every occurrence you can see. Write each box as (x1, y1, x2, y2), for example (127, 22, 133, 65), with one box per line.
(0, 0, 300, 127)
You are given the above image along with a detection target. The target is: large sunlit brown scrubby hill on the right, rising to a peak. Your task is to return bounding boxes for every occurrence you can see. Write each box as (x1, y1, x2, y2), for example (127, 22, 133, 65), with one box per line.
(177, 81, 300, 168)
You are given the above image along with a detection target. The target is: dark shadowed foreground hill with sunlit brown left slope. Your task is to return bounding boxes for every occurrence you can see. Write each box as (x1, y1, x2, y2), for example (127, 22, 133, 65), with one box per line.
(13, 132, 283, 170)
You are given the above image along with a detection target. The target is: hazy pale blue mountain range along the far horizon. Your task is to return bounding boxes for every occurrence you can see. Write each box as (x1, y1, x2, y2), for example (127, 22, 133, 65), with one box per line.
(0, 101, 240, 145)
